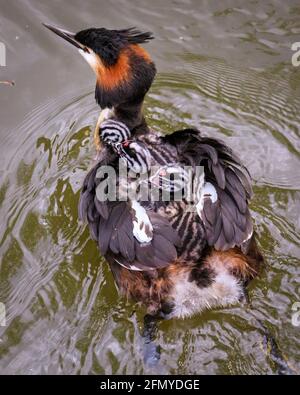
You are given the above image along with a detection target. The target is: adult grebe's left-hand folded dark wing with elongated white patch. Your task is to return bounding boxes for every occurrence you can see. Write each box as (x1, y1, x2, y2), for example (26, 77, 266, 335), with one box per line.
(79, 161, 180, 270)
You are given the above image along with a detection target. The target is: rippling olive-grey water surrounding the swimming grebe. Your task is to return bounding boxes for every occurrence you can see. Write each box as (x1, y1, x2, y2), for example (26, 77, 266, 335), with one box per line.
(0, 1, 300, 374)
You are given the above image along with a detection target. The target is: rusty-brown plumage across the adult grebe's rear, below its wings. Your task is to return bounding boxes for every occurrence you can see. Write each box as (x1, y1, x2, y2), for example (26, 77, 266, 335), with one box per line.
(108, 239, 263, 317)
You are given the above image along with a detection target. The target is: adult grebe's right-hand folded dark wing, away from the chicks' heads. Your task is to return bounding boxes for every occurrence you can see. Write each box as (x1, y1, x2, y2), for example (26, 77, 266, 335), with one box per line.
(164, 129, 253, 251)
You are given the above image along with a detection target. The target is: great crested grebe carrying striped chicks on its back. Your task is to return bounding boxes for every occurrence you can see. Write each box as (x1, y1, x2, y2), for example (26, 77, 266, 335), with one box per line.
(45, 25, 263, 334)
